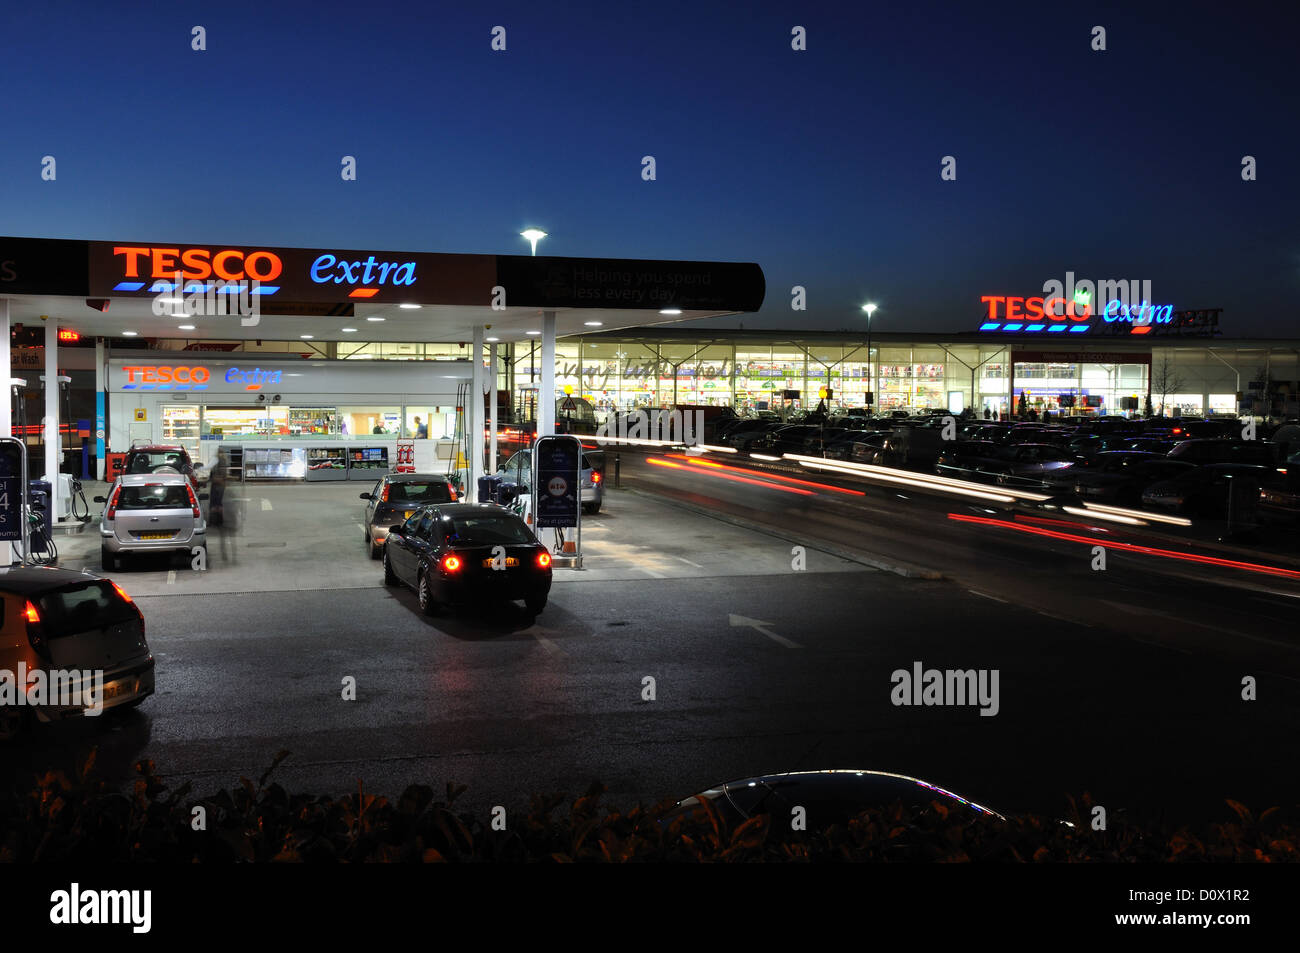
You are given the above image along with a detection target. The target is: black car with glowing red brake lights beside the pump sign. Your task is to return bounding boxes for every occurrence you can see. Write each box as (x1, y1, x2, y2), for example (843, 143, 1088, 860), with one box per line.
(384, 503, 551, 615)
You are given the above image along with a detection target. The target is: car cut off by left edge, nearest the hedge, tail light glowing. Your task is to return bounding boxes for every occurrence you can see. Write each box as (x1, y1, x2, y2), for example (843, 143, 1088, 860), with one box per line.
(0, 567, 153, 740)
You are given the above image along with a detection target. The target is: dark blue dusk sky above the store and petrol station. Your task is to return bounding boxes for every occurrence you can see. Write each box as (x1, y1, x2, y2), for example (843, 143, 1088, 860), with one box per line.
(0, 1, 1300, 337)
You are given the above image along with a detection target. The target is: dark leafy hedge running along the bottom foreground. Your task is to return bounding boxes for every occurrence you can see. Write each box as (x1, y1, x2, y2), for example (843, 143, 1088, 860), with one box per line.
(0, 751, 1300, 863)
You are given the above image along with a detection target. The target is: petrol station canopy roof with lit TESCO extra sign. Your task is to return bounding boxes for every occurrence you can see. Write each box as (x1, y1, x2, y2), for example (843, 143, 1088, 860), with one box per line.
(0, 238, 766, 342)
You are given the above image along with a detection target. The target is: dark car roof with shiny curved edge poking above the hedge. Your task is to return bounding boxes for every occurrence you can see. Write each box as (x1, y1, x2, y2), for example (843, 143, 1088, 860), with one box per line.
(666, 770, 1005, 837)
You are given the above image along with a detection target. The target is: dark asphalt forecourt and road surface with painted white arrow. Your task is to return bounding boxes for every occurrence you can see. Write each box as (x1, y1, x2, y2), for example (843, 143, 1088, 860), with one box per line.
(4, 475, 1300, 820)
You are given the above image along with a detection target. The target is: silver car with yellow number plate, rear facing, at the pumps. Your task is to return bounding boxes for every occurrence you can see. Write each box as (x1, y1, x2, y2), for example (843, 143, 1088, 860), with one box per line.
(95, 471, 208, 569)
